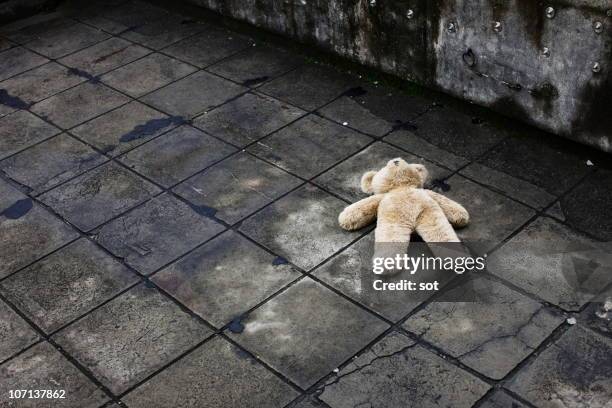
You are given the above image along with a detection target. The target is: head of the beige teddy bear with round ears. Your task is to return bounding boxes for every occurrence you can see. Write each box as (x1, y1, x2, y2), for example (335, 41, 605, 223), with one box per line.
(361, 158, 427, 194)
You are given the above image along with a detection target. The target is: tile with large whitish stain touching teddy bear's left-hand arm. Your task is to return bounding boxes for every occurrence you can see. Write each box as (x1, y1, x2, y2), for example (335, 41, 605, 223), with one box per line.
(240, 185, 359, 270)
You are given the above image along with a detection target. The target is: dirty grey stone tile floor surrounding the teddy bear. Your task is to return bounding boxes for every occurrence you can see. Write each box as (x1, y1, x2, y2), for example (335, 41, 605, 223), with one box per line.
(0, 1, 612, 408)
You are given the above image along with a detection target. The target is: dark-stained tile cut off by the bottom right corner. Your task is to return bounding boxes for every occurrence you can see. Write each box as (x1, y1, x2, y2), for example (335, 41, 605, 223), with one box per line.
(506, 326, 612, 408)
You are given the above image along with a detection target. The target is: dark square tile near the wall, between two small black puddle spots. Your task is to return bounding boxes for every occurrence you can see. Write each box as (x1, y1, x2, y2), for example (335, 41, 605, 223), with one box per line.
(260, 65, 356, 110)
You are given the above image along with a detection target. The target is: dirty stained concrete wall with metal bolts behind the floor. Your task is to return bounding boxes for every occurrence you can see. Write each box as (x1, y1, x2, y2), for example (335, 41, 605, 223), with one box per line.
(187, 0, 612, 152)
